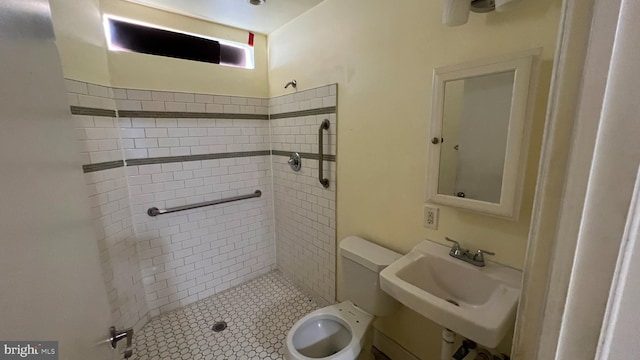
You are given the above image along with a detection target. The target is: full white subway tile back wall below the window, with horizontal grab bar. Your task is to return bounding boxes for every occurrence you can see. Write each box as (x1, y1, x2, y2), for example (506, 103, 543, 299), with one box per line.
(114, 89, 275, 316)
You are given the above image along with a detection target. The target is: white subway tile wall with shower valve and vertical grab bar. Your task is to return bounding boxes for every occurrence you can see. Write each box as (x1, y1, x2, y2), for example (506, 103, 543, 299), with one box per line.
(270, 85, 337, 305)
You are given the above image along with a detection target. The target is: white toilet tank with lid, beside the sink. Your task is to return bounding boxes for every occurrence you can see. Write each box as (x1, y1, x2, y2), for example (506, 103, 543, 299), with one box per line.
(340, 236, 402, 316)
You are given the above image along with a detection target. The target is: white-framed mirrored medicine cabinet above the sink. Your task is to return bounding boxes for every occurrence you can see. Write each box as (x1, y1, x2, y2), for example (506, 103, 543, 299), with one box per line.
(426, 49, 541, 220)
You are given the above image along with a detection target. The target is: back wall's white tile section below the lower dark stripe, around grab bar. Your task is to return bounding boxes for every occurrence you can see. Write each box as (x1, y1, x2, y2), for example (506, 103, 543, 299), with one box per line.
(127, 156, 275, 316)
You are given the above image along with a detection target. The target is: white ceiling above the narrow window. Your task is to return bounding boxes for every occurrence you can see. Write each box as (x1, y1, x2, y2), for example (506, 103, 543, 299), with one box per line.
(127, 0, 322, 34)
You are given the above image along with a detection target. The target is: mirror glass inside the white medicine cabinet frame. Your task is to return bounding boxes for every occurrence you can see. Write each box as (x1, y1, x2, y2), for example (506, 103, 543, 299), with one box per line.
(438, 70, 515, 204)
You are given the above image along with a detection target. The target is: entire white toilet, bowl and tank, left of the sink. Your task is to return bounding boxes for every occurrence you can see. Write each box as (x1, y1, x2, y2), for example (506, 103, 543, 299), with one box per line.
(286, 236, 402, 360)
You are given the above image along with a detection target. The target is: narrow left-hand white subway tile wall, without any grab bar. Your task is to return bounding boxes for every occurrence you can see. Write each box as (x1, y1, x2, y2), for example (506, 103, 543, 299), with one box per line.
(66, 80, 149, 330)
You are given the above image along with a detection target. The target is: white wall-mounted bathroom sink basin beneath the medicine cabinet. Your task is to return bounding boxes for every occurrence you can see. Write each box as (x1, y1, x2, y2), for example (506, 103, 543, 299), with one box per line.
(380, 241, 522, 348)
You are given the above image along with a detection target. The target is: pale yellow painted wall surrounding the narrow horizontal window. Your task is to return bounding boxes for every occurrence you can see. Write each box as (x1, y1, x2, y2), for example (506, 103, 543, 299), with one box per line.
(50, 0, 268, 97)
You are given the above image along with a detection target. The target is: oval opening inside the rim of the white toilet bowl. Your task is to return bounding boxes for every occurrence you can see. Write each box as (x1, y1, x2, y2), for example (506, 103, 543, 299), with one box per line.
(292, 316, 351, 359)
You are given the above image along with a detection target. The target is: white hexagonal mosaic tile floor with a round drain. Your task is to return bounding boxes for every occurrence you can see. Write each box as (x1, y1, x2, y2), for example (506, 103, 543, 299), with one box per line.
(131, 271, 318, 360)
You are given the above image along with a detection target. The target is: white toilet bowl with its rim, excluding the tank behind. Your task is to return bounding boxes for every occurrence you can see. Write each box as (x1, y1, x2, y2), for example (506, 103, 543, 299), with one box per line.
(286, 301, 373, 360)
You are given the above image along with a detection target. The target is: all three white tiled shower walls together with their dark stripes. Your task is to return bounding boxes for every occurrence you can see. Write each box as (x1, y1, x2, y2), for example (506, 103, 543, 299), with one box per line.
(66, 80, 337, 352)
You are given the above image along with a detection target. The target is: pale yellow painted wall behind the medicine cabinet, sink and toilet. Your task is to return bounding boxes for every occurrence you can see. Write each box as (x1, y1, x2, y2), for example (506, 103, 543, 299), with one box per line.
(269, 0, 561, 359)
